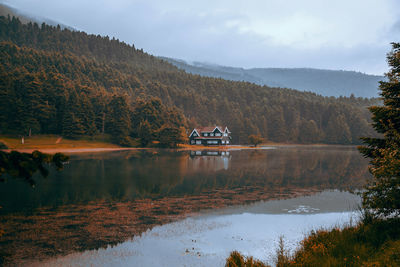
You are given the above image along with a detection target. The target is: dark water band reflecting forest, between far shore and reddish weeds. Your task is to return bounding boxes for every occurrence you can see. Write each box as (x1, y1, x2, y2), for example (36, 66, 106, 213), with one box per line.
(0, 147, 369, 213)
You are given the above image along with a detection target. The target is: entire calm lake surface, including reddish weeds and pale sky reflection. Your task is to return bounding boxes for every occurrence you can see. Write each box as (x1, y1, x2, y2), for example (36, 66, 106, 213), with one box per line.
(0, 146, 370, 266)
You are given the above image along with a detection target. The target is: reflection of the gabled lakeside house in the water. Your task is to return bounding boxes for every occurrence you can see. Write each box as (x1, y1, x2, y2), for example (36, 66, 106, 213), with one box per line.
(189, 150, 232, 171)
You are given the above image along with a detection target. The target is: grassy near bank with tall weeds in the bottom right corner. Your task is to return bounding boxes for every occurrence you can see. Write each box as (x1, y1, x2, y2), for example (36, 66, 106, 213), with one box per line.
(226, 218, 400, 267)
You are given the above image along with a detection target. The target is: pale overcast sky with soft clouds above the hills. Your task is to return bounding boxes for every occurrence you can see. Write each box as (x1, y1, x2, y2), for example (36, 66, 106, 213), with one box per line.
(0, 0, 400, 74)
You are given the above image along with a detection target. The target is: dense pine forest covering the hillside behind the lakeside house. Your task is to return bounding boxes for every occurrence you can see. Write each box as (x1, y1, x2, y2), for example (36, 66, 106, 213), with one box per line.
(0, 17, 377, 145)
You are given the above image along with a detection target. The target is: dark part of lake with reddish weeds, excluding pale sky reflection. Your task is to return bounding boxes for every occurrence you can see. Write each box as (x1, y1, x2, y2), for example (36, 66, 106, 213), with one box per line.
(0, 149, 369, 266)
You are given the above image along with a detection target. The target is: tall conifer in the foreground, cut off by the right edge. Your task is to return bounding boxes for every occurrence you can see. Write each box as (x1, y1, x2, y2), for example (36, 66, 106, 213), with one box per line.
(359, 43, 400, 219)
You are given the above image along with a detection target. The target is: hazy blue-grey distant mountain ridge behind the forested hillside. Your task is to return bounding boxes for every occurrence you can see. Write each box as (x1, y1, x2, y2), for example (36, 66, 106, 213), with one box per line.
(161, 57, 384, 98)
